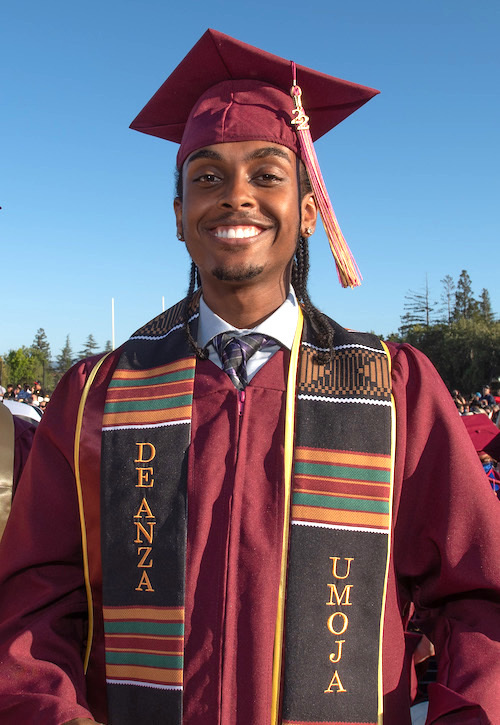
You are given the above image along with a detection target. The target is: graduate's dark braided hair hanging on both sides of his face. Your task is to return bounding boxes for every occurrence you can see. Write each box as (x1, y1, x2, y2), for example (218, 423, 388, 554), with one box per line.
(175, 162, 333, 364)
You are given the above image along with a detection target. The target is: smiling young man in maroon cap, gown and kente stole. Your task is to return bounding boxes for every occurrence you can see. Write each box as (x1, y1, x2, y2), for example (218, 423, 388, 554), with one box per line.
(0, 31, 500, 725)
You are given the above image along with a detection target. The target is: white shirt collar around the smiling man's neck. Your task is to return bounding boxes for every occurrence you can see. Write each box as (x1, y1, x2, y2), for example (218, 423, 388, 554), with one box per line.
(198, 287, 299, 350)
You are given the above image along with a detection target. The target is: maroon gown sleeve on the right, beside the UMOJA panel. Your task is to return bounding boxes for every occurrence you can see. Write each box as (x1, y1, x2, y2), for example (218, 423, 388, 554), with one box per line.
(389, 345, 500, 725)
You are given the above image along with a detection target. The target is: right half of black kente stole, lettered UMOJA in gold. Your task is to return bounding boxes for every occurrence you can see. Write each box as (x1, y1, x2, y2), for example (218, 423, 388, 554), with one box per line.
(277, 322, 394, 725)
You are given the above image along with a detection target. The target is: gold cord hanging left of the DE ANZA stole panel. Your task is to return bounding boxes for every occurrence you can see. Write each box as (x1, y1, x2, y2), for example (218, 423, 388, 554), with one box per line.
(74, 352, 111, 674)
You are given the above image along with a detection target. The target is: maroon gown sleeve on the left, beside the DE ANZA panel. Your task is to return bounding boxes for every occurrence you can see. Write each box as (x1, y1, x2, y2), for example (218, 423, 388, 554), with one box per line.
(0, 361, 98, 725)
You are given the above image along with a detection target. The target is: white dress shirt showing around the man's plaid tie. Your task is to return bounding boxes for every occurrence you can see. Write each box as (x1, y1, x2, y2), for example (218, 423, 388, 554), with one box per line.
(198, 287, 299, 381)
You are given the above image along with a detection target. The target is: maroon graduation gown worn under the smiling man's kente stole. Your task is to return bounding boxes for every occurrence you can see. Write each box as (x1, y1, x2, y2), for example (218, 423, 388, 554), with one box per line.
(0, 345, 500, 725)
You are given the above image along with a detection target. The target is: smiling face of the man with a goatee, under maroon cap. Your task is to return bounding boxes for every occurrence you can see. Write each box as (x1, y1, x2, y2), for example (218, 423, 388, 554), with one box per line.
(174, 141, 316, 309)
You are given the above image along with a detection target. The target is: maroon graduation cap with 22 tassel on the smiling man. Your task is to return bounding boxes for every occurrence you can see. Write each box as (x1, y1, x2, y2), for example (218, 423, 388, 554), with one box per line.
(130, 29, 378, 287)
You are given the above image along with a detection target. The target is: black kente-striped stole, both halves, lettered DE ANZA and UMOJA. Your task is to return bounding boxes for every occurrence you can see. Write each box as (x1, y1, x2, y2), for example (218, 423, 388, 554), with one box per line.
(90, 296, 394, 725)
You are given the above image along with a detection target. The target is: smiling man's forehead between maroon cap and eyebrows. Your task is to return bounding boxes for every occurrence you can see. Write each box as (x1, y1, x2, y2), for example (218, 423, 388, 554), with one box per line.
(184, 141, 297, 168)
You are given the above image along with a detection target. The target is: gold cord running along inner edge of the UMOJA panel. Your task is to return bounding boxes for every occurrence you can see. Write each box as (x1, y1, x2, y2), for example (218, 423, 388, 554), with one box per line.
(271, 307, 304, 725)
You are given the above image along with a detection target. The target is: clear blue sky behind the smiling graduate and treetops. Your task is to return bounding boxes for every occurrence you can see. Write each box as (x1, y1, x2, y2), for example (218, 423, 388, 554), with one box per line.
(0, 0, 500, 354)
